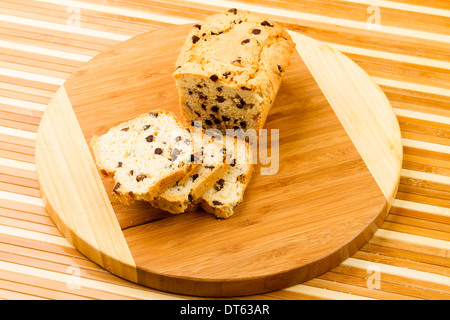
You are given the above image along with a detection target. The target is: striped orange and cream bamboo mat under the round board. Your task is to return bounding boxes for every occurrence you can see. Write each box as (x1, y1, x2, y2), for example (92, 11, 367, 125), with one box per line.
(0, 0, 450, 300)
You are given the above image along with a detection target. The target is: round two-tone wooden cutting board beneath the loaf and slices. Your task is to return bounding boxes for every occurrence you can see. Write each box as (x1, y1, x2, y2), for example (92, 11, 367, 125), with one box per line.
(36, 25, 402, 297)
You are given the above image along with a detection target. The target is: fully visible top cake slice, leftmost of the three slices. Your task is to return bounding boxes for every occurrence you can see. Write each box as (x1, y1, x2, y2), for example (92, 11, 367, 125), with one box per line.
(91, 110, 201, 205)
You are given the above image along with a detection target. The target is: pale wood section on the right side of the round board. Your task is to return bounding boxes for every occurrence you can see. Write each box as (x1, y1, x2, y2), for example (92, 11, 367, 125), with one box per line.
(290, 32, 403, 199)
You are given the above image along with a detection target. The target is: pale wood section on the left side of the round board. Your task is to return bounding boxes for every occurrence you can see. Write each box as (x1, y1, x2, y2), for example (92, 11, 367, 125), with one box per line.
(36, 86, 137, 281)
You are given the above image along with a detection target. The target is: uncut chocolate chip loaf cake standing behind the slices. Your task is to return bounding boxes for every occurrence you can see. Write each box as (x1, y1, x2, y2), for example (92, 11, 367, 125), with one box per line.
(173, 9, 295, 134)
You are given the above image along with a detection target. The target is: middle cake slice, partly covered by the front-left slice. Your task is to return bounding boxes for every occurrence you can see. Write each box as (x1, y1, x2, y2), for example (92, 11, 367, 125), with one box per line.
(152, 134, 229, 214)
